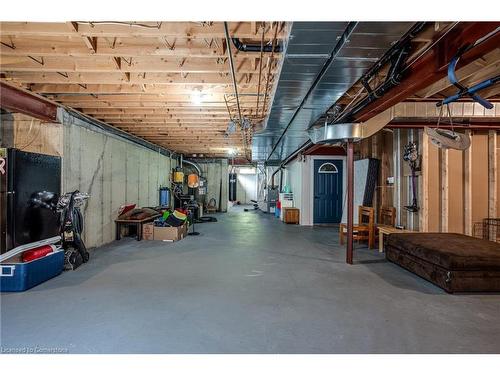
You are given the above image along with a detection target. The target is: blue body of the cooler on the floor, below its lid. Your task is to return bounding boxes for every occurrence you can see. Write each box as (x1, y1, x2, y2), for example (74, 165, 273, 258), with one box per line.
(0, 249, 64, 292)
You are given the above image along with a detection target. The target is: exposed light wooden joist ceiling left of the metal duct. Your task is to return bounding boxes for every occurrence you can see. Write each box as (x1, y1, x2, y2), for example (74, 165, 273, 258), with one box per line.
(0, 22, 287, 157)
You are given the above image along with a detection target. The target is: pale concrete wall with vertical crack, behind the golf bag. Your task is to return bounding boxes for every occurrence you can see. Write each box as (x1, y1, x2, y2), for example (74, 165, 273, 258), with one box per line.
(63, 110, 170, 247)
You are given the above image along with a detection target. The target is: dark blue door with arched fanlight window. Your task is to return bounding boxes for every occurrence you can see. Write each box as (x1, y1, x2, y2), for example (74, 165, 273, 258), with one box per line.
(314, 160, 343, 224)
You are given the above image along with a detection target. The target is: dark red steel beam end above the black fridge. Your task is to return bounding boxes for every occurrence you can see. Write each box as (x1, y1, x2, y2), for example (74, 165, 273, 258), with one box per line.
(0, 82, 57, 121)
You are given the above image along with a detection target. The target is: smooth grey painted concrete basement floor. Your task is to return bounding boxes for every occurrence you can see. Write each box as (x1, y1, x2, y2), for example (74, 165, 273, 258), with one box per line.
(1, 207, 500, 353)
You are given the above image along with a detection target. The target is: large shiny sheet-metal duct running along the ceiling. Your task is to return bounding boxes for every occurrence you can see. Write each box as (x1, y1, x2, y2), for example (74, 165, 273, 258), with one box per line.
(252, 22, 413, 162)
